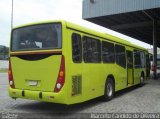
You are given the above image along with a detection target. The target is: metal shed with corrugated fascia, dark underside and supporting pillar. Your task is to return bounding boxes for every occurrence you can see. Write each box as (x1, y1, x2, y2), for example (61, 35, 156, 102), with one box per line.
(82, 0, 160, 79)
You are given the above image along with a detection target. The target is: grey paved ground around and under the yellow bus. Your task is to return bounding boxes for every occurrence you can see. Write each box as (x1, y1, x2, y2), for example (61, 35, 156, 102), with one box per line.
(0, 73, 160, 118)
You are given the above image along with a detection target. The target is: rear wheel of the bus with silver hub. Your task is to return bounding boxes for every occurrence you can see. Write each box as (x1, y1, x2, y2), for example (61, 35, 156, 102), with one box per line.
(104, 78, 114, 101)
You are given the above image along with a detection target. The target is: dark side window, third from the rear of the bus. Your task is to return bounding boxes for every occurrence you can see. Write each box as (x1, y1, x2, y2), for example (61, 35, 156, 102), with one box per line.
(102, 41, 115, 63)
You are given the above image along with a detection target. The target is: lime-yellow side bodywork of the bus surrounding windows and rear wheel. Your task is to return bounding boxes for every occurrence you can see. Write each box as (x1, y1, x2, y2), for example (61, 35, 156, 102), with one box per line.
(63, 26, 148, 104)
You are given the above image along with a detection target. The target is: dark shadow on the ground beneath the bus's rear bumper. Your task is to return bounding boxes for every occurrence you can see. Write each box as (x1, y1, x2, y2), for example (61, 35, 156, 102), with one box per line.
(12, 98, 103, 113)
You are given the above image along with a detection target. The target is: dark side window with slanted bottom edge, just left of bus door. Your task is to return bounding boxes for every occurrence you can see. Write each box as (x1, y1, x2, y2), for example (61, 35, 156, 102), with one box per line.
(115, 45, 126, 68)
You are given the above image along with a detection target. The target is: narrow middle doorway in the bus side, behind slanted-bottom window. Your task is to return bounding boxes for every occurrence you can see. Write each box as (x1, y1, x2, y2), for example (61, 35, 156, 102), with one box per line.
(127, 51, 134, 85)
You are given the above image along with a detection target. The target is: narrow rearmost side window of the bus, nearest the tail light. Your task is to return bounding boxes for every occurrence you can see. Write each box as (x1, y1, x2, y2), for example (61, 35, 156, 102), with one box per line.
(72, 33, 82, 63)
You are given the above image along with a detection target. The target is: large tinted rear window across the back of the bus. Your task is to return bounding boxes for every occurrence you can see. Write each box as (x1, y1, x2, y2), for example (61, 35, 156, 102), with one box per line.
(11, 23, 62, 51)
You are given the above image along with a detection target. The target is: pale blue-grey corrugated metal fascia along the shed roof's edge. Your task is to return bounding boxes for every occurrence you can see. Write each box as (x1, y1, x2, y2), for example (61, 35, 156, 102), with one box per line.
(83, 0, 160, 19)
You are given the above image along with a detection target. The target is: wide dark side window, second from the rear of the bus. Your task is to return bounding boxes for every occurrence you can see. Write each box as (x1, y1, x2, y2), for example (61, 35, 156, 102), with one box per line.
(83, 37, 101, 63)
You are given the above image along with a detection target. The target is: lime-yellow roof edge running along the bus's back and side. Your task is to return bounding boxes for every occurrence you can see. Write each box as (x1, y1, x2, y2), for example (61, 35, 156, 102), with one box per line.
(13, 20, 147, 51)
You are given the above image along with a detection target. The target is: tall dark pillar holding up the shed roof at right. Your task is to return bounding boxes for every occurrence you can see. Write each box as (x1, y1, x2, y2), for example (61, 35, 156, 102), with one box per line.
(153, 20, 158, 79)
